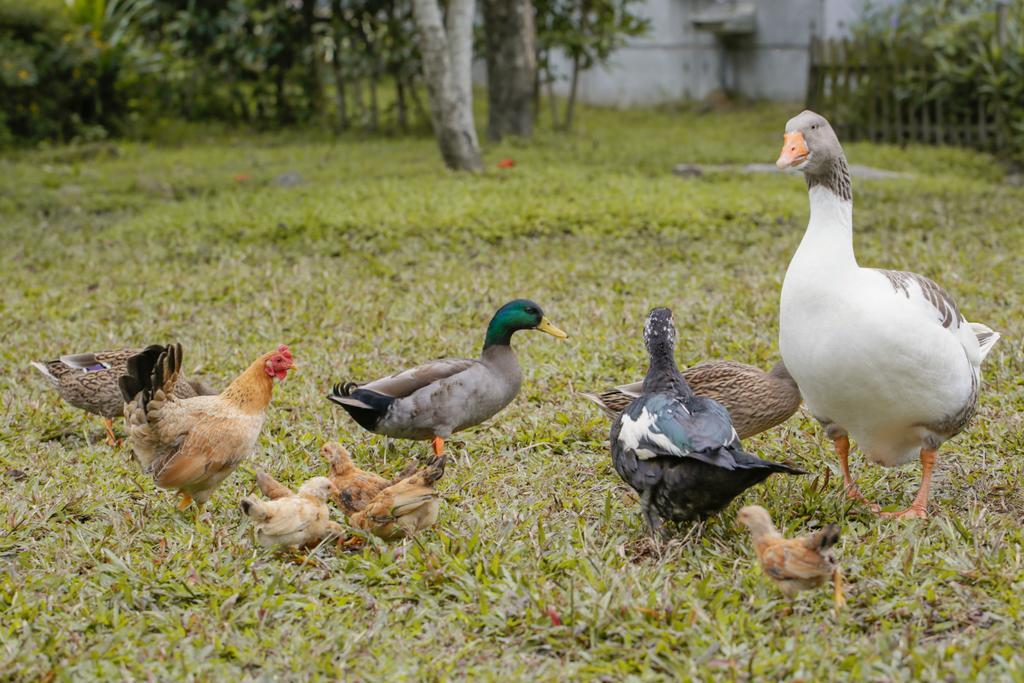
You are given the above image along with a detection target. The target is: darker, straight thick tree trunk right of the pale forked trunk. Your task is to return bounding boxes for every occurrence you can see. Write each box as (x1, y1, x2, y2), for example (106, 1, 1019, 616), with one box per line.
(482, 0, 537, 140)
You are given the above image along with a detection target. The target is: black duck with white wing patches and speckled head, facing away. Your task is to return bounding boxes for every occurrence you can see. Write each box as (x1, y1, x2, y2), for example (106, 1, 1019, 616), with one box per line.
(610, 308, 804, 535)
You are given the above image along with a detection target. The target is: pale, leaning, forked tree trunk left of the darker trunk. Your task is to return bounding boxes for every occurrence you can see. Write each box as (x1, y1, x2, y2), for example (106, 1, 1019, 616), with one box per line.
(413, 0, 483, 171)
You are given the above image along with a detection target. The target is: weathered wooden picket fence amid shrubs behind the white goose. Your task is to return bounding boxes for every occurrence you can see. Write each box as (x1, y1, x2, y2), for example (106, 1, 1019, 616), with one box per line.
(807, 39, 1009, 151)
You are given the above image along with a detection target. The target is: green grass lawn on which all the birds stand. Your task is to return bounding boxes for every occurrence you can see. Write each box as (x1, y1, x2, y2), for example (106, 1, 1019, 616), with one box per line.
(0, 106, 1024, 681)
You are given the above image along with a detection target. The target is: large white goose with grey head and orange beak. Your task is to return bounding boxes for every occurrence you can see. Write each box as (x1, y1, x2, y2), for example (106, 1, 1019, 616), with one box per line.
(776, 112, 999, 517)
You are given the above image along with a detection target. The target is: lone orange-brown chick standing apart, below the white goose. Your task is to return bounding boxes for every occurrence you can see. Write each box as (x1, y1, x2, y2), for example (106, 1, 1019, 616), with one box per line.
(736, 505, 846, 607)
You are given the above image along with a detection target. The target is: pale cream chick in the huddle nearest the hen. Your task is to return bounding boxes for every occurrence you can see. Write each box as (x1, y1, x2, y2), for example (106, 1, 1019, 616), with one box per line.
(241, 472, 345, 548)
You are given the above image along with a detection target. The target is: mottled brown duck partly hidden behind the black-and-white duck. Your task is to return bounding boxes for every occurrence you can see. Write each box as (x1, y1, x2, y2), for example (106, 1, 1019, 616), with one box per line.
(583, 360, 800, 438)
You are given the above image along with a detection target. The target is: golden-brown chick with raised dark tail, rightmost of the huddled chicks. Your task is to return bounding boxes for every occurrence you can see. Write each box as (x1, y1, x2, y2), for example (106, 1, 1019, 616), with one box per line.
(348, 456, 447, 541)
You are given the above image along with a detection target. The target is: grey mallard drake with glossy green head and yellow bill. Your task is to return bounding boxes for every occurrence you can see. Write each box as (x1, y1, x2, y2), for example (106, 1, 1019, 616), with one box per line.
(328, 299, 568, 456)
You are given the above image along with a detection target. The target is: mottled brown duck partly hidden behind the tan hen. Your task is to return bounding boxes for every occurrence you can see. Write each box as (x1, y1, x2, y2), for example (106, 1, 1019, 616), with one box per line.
(32, 346, 216, 445)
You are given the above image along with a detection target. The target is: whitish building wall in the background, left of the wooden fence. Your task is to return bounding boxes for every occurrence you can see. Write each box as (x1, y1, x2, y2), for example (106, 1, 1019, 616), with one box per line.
(556, 0, 895, 106)
